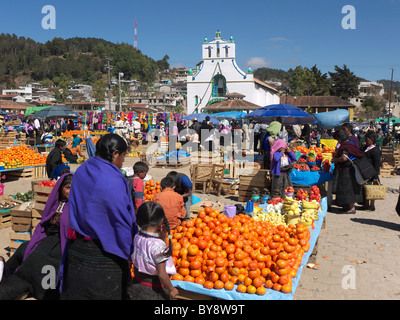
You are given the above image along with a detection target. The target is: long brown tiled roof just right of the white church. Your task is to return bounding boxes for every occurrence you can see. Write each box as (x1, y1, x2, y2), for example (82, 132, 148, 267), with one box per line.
(281, 96, 355, 108)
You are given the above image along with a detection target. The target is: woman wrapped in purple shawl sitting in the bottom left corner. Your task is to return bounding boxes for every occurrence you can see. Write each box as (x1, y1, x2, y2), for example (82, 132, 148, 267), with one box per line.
(0, 173, 72, 300)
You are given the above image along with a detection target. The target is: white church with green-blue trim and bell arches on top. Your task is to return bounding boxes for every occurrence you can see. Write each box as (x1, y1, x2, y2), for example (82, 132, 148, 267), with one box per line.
(187, 31, 280, 114)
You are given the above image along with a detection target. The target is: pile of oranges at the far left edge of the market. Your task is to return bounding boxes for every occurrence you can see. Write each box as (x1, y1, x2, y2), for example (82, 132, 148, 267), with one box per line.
(0, 145, 47, 169)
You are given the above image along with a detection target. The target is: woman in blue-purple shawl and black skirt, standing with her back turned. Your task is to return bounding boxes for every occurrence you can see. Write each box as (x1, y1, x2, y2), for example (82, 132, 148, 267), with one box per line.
(59, 133, 138, 300)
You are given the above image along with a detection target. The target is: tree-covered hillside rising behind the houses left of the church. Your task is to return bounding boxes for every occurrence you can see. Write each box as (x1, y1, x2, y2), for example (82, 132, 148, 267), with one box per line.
(0, 33, 169, 88)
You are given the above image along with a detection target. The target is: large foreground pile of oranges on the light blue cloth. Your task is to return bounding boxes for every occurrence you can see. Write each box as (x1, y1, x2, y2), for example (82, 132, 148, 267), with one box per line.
(171, 207, 310, 295)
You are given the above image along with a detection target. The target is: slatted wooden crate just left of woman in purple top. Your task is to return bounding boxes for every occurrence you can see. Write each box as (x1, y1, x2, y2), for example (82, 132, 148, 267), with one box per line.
(238, 169, 271, 202)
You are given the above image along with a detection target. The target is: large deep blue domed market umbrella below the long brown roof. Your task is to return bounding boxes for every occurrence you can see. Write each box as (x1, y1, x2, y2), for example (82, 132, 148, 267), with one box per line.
(246, 103, 315, 125)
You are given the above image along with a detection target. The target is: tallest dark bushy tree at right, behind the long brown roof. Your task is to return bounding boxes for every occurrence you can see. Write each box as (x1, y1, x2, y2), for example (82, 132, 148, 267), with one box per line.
(329, 65, 360, 100)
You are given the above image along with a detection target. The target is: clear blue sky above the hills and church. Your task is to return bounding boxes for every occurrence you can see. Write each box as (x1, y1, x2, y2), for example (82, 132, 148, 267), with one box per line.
(0, 0, 400, 81)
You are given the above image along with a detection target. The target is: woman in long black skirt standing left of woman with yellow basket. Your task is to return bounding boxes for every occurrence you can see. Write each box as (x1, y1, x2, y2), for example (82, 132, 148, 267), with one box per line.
(332, 130, 365, 213)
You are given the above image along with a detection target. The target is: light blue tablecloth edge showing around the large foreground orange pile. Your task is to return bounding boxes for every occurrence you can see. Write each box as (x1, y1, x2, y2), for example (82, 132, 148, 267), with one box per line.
(171, 198, 328, 300)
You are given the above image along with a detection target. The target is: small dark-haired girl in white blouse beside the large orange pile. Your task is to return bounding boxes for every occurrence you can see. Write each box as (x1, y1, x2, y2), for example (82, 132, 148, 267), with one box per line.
(128, 201, 178, 300)
